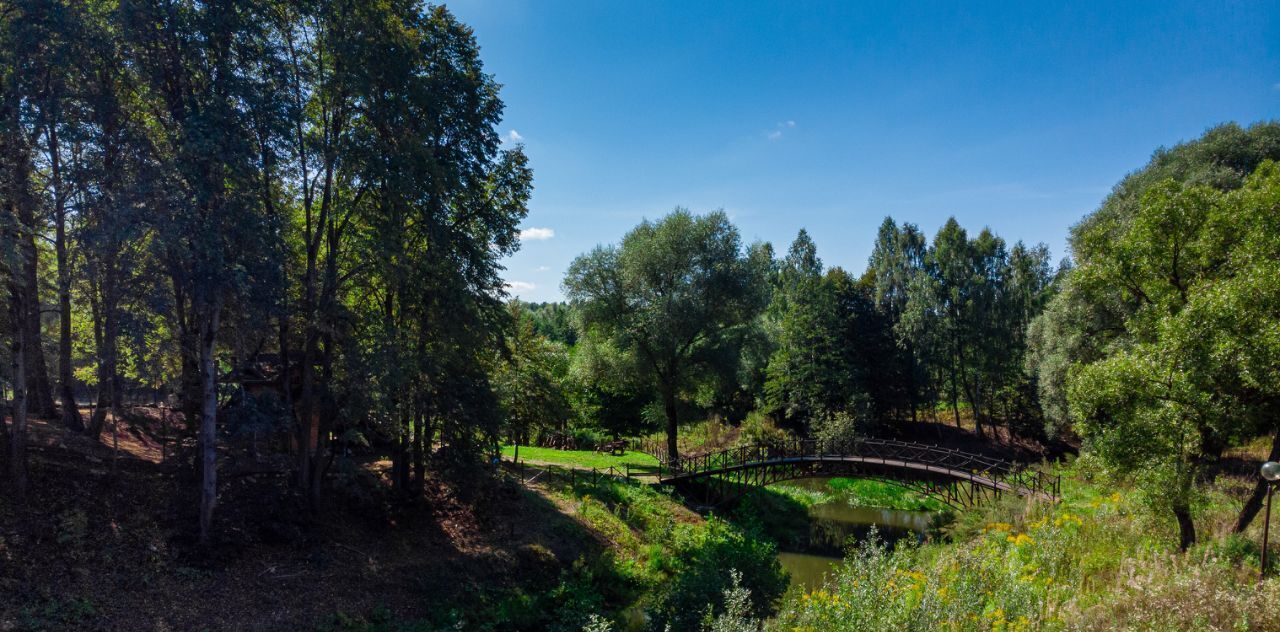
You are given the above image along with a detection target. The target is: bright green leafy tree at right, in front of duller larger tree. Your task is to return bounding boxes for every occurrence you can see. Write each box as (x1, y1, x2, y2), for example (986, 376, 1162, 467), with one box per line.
(1041, 151, 1280, 546)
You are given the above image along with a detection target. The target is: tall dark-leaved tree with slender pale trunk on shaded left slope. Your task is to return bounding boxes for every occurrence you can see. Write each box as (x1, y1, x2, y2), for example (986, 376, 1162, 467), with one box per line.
(120, 0, 288, 541)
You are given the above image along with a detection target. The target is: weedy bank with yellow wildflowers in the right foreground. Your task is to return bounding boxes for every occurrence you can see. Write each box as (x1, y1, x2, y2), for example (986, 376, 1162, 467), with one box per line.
(767, 480, 1280, 631)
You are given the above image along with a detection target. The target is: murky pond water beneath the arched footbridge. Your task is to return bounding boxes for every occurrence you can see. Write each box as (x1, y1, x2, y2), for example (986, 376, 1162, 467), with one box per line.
(778, 478, 937, 590)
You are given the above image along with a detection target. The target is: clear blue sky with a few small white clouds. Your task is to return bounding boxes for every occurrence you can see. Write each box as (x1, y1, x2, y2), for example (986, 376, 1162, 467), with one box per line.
(448, 0, 1280, 301)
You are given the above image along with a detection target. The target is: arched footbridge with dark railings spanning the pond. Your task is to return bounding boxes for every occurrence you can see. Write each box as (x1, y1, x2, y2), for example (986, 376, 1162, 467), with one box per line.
(632, 439, 1061, 508)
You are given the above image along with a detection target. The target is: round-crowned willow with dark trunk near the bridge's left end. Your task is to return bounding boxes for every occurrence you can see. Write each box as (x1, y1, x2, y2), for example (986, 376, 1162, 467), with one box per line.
(564, 209, 771, 459)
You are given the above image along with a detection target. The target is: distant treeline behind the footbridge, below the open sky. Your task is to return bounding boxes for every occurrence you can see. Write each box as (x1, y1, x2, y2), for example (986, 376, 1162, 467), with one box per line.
(506, 211, 1056, 458)
